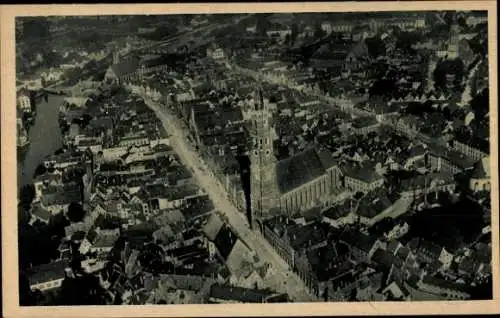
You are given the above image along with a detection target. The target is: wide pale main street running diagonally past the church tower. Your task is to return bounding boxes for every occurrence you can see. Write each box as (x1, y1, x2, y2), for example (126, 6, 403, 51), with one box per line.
(135, 90, 317, 302)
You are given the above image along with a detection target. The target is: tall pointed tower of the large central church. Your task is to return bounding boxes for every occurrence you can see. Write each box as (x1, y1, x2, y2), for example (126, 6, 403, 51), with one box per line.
(250, 85, 278, 222)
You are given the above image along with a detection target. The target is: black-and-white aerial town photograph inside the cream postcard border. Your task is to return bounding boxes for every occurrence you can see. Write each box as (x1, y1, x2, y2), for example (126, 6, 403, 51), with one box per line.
(15, 11, 493, 306)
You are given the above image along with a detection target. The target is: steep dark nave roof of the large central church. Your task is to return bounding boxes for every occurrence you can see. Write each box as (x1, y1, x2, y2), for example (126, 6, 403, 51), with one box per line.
(276, 148, 335, 193)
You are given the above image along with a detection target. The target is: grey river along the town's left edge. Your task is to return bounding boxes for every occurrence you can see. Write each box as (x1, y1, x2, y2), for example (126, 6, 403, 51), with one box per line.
(17, 94, 64, 188)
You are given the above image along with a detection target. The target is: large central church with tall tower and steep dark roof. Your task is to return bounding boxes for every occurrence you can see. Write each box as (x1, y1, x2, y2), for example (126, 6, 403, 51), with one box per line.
(249, 85, 342, 220)
